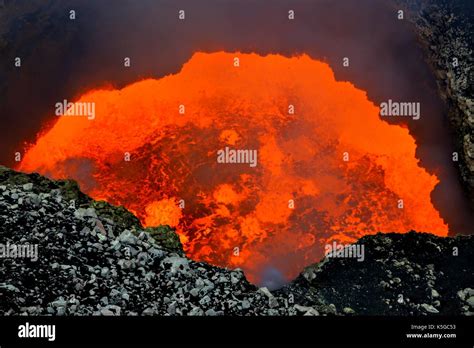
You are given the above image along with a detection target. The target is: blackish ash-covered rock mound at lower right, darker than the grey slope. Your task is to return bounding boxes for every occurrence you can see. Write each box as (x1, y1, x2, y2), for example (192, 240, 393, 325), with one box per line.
(277, 232, 474, 315)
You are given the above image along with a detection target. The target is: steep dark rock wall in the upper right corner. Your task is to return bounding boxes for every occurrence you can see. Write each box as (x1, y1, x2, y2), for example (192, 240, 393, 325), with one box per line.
(396, 0, 474, 207)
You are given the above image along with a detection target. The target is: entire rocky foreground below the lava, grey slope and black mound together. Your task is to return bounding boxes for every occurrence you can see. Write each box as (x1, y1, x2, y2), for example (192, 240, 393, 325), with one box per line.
(0, 167, 474, 315)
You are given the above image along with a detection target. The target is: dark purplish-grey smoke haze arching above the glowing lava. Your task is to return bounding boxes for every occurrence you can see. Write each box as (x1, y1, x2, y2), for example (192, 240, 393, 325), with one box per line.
(0, 0, 474, 239)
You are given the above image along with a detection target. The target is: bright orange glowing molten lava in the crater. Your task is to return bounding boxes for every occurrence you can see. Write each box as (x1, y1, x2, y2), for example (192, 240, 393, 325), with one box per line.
(19, 52, 448, 282)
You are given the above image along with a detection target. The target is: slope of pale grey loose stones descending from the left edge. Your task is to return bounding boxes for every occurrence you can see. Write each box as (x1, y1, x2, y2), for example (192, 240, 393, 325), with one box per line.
(0, 167, 296, 315)
